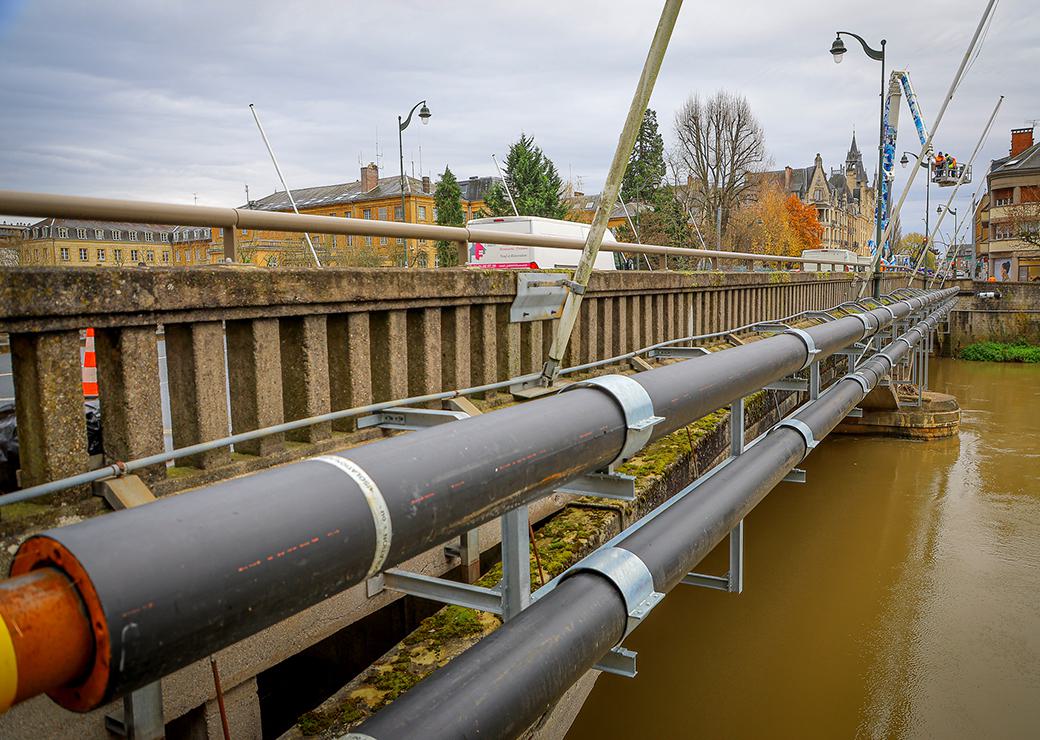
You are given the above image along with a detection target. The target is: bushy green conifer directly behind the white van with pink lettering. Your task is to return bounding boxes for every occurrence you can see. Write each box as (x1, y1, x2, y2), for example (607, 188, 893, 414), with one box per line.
(484, 133, 567, 218)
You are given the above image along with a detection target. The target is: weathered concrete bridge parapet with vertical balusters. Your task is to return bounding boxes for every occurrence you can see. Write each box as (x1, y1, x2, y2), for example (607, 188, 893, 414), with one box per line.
(0, 266, 900, 495)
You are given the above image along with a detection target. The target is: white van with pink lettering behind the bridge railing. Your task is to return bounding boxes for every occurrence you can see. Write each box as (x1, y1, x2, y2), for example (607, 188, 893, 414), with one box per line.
(466, 216, 620, 270)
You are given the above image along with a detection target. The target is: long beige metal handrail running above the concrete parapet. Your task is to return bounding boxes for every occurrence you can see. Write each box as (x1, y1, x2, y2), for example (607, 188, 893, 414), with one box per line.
(0, 190, 873, 265)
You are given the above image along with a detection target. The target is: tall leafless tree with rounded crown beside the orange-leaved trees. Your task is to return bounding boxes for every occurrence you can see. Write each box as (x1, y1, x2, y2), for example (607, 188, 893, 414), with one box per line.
(671, 90, 766, 243)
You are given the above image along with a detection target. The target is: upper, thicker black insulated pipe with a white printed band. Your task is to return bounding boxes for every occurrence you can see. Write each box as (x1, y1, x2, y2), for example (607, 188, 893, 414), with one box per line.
(10, 291, 944, 709)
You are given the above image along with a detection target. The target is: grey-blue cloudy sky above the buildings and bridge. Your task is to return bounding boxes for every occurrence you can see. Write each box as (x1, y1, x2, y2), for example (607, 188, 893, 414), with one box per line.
(0, 0, 1040, 243)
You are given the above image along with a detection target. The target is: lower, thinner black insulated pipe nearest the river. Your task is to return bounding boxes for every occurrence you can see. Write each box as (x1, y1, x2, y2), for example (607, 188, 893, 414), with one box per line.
(347, 291, 956, 740)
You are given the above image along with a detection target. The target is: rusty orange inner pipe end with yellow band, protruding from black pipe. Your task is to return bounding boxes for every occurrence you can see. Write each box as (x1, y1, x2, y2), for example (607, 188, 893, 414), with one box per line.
(0, 567, 94, 711)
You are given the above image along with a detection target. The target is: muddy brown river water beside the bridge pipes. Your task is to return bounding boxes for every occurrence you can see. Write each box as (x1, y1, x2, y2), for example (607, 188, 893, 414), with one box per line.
(568, 360, 1040, 740)
